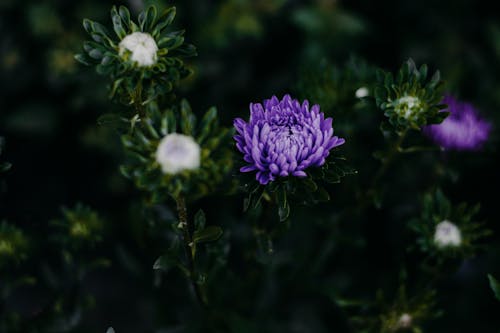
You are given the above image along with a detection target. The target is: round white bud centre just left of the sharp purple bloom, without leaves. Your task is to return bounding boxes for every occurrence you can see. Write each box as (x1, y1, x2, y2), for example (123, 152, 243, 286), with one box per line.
(156, 133, 201, 174)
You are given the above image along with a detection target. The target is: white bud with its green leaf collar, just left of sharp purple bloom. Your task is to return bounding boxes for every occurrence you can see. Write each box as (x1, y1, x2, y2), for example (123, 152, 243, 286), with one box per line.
(120, 100, 233, 202)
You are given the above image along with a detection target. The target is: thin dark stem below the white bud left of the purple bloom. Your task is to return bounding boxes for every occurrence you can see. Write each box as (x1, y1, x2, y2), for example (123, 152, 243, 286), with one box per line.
(176, 194, 207, 306)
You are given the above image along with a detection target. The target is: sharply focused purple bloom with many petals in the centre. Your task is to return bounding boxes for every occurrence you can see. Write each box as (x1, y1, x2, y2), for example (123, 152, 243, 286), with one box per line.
(234, 95, 345, 185)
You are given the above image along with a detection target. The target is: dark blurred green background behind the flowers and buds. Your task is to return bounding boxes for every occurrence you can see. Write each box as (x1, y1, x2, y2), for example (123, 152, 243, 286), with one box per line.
(0, 0, 500, 333)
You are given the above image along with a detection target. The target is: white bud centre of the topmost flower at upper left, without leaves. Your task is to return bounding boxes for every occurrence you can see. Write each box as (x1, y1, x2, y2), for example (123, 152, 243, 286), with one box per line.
(119, 32, 158, 67)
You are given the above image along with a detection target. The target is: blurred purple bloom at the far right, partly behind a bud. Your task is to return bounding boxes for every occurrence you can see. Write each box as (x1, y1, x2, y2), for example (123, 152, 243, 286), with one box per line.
(422, 95, 491, 150)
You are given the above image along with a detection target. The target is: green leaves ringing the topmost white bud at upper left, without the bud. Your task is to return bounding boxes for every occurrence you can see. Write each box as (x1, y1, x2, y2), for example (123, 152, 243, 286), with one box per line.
(76, 6, 196, 105)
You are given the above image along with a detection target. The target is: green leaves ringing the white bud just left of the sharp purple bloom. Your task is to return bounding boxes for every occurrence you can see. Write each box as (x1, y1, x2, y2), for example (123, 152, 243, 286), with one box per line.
(121, 100, 233, 202)
